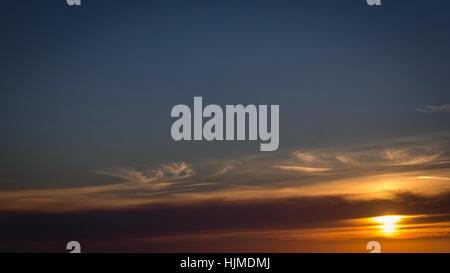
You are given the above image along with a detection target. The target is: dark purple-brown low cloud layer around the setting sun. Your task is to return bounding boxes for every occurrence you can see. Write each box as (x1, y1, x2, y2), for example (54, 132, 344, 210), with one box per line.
(0, 193, 450, 251)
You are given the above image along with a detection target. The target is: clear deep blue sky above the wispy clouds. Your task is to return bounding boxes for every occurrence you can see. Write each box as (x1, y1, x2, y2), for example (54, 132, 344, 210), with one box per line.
(0, 0, 450, 189)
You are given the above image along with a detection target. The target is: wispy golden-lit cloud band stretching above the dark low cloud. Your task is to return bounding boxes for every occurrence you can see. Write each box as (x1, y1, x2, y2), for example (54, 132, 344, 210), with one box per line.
(0, 134, 450, 212)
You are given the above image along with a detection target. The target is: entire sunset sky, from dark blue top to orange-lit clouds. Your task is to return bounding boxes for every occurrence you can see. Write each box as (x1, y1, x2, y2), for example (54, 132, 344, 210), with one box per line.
(0, 0, 450, 252)
